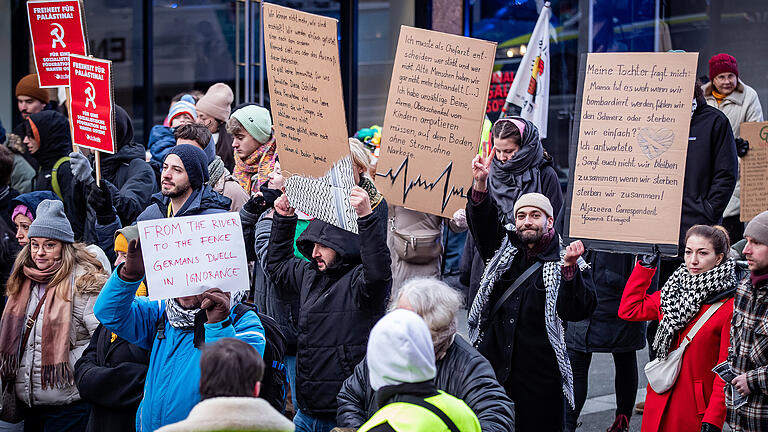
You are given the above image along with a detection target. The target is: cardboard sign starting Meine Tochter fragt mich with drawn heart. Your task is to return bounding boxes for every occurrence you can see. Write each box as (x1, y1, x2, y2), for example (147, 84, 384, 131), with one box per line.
(565, 53, 699, 255)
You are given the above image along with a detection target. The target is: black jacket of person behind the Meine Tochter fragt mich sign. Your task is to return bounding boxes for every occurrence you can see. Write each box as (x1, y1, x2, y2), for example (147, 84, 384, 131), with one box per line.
(678, 101, 739, 250)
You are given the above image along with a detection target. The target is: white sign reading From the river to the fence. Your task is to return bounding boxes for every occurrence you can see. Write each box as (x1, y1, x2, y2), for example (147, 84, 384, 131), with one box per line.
(138, 212, 249, 300)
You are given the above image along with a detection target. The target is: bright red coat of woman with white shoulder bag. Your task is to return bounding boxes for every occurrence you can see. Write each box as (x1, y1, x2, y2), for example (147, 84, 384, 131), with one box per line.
(619, 263, 733, 432)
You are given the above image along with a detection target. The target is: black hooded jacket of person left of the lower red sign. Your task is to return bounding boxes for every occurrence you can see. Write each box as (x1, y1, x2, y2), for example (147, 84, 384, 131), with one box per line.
(29, 111, 85, 239)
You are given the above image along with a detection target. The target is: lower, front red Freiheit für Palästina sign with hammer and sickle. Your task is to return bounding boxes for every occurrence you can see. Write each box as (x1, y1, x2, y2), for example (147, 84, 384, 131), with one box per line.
(69, 55, 115, 153)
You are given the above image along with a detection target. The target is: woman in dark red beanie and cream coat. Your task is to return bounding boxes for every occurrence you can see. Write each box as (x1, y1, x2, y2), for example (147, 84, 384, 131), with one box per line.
(702, 53, 763, 242)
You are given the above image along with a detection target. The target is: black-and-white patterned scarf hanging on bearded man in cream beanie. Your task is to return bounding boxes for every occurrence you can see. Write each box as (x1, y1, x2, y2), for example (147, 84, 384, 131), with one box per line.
(467, 224, 575, 408)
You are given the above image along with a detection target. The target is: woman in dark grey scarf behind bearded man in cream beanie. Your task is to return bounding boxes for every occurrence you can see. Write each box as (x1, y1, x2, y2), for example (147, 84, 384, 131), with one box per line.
(463, 117, 563, 304)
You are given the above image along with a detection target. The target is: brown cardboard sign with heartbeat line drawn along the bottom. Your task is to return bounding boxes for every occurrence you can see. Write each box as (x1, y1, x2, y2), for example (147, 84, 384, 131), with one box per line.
(376, 26, 496, 217)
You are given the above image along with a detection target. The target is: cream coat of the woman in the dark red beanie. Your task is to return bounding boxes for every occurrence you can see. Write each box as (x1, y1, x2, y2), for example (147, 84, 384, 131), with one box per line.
(702, 80, 763, 217)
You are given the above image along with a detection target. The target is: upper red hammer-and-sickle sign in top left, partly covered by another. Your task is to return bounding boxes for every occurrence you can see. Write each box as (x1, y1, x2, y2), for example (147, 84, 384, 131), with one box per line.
(27, 0, 88, 88)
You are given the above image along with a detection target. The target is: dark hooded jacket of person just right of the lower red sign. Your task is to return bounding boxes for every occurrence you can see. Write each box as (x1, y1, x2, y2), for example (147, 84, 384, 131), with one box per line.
(79, 106, 157, 250)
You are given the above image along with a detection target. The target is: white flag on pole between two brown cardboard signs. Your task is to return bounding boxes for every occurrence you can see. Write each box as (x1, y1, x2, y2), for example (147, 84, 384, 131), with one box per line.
(507, 2, 552, 138)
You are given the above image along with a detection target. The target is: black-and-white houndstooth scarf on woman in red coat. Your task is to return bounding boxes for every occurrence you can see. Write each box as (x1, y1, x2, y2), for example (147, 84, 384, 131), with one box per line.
(653, 258, 736, 360)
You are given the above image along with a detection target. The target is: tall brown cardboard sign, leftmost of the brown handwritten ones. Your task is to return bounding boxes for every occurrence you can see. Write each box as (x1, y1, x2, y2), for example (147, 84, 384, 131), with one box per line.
(262, 3, 349, 177)
